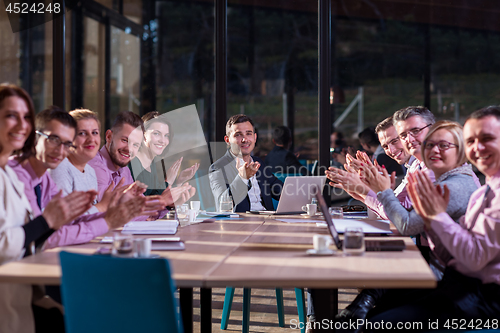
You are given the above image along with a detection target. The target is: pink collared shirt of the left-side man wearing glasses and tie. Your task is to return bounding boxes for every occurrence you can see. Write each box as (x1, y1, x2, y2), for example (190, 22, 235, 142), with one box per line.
(8, 160, 109, 249)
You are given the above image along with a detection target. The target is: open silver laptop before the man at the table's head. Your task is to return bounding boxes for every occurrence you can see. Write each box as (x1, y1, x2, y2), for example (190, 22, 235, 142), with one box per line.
(250, 176, 326, 215)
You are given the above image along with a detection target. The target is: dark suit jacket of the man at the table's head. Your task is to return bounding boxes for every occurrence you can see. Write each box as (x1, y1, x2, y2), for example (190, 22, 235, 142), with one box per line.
(208, 150, 283, 213)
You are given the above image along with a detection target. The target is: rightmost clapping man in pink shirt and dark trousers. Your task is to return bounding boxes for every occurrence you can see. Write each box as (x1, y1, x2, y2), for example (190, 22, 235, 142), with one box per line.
(368, 106, 500, 331)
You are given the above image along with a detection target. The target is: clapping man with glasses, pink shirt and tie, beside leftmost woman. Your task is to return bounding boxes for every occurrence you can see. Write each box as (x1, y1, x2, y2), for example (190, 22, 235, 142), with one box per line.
(9, 107, 158, 248)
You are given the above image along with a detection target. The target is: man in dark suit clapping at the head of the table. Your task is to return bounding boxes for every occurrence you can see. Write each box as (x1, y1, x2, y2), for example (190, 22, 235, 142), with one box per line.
(208, 114, 283, 212)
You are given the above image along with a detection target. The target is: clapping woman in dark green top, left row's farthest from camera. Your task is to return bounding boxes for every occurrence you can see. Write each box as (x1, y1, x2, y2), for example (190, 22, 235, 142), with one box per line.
(129, 111, 200, 197)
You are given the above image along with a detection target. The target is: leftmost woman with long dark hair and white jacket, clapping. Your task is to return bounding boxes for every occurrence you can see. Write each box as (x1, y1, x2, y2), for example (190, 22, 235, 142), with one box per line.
(0, 84, 95, 333)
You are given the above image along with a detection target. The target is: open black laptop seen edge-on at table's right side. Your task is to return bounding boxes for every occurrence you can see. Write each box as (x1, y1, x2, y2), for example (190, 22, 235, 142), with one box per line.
(316, 188, 406, 251)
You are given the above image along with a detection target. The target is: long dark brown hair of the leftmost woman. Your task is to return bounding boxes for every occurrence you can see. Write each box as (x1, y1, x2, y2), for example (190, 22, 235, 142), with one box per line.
(0, 83, 35, 155)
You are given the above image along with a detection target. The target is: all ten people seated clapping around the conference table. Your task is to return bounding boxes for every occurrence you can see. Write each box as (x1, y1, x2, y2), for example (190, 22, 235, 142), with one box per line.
(0, 84, 500, 332)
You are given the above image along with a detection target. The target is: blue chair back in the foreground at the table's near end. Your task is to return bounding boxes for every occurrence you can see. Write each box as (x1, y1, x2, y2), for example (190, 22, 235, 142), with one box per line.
(60, 252, 183, 333)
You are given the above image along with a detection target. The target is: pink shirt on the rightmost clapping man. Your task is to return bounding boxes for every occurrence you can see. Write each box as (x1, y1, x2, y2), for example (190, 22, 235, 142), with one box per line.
(426, 171, 500, 284)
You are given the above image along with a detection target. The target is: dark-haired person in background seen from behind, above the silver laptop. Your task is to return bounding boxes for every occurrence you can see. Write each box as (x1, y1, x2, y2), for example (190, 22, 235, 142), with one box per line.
(266, 126, 307, 176)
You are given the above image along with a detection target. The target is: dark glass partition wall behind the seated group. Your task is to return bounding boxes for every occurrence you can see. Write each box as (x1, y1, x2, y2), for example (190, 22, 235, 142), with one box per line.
(0, 0, 500, 169)
